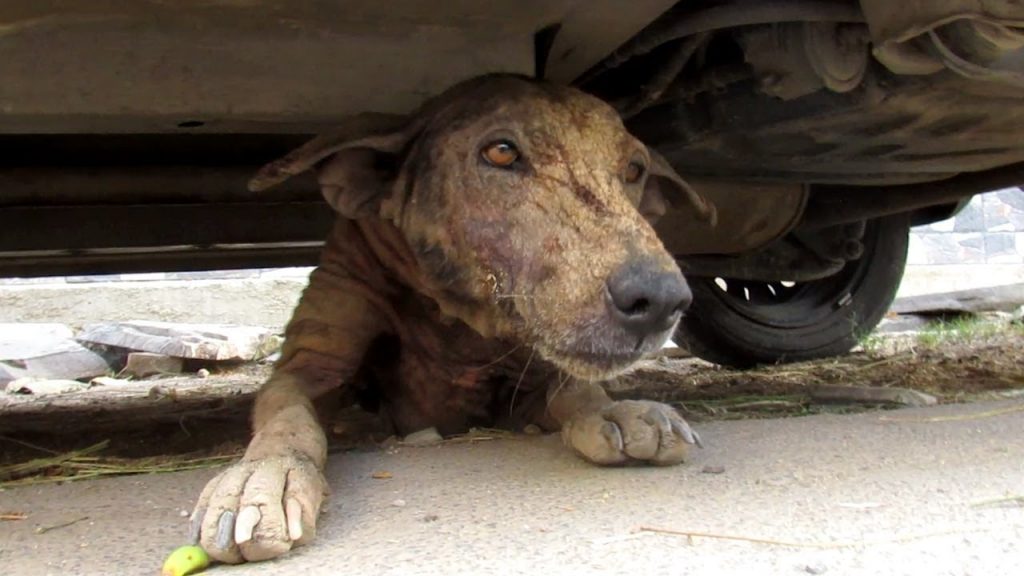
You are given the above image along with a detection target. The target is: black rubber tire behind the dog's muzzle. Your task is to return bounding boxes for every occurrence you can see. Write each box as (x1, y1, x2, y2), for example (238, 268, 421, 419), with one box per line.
(674, 214, 910, 368)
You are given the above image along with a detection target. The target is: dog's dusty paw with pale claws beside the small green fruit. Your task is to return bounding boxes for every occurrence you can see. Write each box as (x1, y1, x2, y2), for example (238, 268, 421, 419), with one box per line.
(190, 456, 327, 564)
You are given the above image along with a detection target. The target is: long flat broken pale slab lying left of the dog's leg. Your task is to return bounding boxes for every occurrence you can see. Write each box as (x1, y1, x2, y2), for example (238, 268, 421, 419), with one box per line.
(78, 321, 282, 362)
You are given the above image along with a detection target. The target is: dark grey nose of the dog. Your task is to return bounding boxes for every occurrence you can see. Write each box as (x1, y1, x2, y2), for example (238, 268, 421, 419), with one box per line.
(607, 256, 693, 338)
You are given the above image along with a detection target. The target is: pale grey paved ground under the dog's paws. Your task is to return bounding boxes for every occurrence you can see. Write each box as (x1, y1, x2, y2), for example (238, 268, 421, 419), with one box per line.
(0, 399, 1024, 576)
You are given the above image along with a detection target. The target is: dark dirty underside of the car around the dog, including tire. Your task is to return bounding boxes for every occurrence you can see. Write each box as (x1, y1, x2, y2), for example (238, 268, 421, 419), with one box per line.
(0, 0, 1024, 365)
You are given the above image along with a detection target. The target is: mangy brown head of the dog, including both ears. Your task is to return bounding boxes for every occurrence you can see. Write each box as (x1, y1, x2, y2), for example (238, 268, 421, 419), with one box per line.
(251, 76, 714, 379)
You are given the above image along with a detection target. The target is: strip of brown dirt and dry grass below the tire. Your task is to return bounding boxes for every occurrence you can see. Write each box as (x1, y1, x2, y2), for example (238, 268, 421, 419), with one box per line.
(611, 323, 1024, 419)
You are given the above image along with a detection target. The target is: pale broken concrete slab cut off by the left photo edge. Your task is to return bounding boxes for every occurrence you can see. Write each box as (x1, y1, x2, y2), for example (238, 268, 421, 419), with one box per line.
(0, 323, 111, 389)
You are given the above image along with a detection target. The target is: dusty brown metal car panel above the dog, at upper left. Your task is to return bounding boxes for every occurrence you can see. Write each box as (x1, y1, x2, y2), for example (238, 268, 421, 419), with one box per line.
(0, 0, 552, 133)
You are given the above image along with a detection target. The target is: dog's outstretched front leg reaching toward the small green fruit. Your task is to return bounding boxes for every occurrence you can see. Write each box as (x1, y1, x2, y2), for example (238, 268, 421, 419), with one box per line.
(190, 241, 385, 564)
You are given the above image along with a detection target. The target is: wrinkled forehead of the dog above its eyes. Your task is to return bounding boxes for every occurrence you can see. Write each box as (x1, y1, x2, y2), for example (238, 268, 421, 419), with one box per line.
(421, 79, 639, 153)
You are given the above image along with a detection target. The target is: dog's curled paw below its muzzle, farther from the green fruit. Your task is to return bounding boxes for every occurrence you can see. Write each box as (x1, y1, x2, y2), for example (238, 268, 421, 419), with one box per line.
(562, 400, 700, 465)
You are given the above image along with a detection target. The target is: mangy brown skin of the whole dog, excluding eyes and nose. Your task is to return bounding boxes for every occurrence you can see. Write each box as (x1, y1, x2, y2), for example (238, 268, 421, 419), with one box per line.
(193, 76, 711, 563)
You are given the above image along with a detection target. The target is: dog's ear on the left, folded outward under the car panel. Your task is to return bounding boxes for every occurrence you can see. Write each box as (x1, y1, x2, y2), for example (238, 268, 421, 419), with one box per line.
(249, 114, 419, 218)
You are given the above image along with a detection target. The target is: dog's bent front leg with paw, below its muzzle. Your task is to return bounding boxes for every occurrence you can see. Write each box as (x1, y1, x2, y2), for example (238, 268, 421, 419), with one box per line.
(548, 379, 700, 465)
